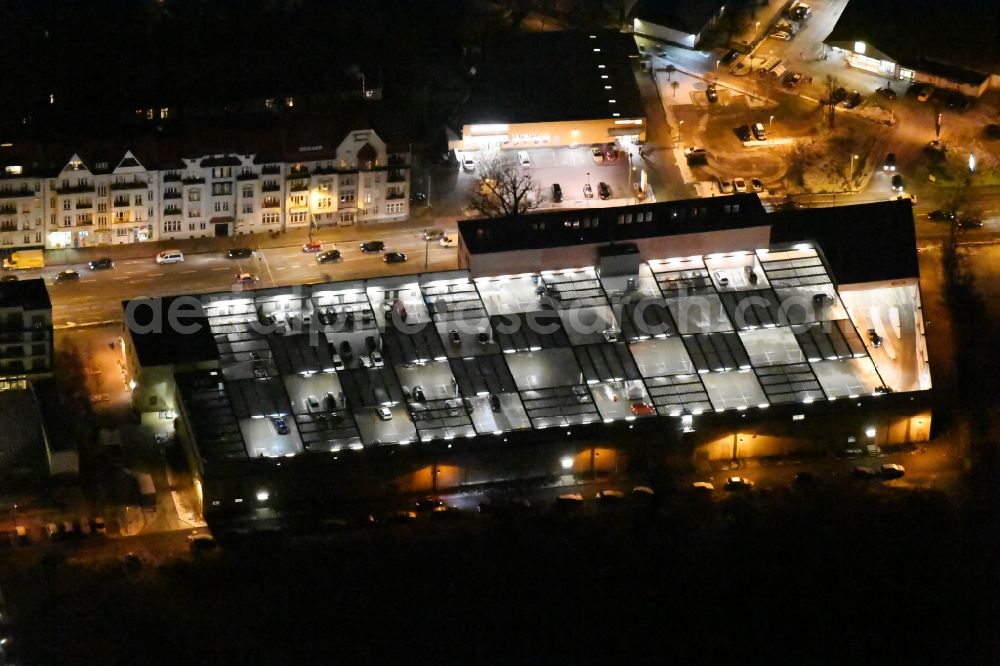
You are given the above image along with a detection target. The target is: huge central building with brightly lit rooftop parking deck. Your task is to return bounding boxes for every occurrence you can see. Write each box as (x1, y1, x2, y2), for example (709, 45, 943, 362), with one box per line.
(123, 195, 931, 522)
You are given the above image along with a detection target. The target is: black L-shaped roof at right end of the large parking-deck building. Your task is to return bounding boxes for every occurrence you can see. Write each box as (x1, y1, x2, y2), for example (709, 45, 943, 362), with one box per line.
(768, 199, 920, 284)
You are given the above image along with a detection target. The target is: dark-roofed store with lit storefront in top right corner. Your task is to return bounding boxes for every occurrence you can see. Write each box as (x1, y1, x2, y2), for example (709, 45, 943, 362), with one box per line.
(824, 0, 1000, 97)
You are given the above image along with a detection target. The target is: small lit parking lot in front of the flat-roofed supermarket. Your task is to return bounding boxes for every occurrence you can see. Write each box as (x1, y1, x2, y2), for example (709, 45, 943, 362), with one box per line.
(458, 146, 642, 208)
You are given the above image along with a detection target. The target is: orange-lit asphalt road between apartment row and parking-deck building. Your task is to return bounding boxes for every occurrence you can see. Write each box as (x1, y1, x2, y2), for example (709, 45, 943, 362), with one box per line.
(34, 224, 458, 327)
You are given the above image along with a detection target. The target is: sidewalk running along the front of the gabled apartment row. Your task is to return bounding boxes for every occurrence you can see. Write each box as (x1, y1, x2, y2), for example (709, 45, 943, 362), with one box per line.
(45, 206, 450, 266)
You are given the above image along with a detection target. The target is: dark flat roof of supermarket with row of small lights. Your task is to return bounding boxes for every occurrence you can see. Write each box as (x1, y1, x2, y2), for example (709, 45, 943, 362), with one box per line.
(456, 31, 646, 128)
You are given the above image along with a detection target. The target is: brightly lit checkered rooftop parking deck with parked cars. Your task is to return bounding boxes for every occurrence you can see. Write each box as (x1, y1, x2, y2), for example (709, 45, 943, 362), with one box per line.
(154, 237, 929, 459)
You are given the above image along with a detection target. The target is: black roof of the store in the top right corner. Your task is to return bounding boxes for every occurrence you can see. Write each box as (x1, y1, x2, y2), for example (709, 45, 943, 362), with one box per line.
(826, 0, 1000, 73)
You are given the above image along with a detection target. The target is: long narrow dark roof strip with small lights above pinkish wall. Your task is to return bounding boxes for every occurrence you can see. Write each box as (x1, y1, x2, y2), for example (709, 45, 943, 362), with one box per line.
(458, 194, 768, 254)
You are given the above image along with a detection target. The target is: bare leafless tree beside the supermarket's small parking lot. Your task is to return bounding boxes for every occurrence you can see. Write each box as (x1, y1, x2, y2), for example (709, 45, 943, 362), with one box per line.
(469, 152, 542, 220)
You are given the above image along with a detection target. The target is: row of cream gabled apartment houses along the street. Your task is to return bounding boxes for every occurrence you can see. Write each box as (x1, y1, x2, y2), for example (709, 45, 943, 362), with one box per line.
(0, 129, 410, 250)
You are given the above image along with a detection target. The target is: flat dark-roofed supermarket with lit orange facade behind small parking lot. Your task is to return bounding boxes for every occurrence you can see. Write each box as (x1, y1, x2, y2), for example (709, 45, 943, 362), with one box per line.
(448, 31, 646, 156)
